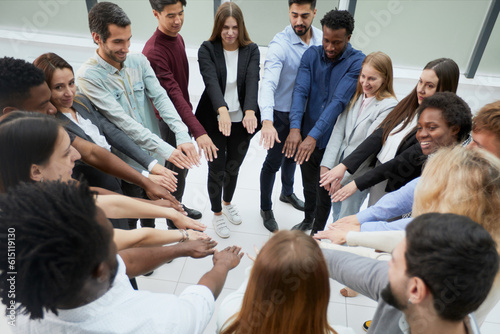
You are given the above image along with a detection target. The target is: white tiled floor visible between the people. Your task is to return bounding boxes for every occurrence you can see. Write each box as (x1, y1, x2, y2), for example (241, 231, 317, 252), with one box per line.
(138, 134, 500, 334)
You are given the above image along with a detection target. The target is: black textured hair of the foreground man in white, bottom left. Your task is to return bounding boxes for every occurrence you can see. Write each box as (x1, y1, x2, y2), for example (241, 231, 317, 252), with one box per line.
(0, 181, 111, 319)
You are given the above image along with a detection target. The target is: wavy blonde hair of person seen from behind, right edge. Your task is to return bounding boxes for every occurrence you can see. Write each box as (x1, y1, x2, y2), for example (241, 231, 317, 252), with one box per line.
(413, 146, 500, 237)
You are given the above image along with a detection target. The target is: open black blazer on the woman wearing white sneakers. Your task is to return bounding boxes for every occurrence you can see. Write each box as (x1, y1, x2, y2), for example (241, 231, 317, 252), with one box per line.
(195, 39, 261, 133)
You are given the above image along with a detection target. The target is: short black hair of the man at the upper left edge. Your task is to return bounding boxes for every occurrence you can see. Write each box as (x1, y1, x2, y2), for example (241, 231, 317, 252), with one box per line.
(0, 57, 45, 111)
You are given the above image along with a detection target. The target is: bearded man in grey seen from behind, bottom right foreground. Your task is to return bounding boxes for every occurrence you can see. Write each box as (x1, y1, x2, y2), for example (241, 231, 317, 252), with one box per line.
(323, 213, 499, 334)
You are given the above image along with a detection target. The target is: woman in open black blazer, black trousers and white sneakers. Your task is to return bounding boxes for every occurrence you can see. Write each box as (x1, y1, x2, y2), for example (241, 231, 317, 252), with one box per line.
(196, 2, 260, 238)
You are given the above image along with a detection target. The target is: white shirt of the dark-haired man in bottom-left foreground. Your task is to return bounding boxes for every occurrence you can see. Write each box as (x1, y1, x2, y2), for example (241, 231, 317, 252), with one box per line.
(13, 255, 215, 334)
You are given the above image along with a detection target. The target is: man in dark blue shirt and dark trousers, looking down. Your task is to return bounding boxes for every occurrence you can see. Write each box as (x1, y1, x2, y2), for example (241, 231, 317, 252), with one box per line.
(283, 10, 365, 233)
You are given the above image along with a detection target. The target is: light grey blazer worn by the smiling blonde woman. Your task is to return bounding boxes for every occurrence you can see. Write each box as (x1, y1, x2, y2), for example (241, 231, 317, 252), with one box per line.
(321, 95, 398, 184)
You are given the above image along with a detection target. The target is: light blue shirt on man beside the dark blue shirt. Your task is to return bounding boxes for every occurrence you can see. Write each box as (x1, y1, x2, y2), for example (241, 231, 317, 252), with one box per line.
(259, 25, 323, 121)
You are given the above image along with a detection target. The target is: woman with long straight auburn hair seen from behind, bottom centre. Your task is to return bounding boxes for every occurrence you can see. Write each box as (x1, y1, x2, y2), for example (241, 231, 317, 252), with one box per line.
(217, 231, 354, 334)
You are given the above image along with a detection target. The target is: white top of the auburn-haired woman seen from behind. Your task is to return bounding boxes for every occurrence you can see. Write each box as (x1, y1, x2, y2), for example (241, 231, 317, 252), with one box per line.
(215, 266, 355, 334)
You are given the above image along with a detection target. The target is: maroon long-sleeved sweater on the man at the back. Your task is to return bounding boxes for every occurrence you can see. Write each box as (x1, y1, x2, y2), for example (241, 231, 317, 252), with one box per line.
(142, 29, 207, 139)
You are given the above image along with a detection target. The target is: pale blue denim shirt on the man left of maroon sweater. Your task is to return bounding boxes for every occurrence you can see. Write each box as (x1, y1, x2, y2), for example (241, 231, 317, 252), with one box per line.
(76, 52, 191, 162)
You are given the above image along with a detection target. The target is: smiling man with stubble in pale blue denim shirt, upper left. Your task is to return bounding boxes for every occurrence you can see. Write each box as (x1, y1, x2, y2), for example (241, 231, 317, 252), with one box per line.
(76, 2, 200, 227)
